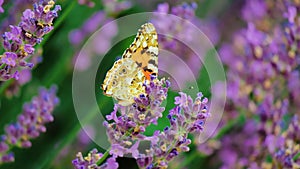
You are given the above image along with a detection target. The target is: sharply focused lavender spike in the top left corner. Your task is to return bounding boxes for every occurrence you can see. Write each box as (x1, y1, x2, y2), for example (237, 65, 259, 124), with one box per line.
(0, 0, 61, 81)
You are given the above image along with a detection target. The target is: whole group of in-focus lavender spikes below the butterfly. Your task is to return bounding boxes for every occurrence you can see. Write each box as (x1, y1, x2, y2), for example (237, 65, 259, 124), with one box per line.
(73, 79, 209, 169)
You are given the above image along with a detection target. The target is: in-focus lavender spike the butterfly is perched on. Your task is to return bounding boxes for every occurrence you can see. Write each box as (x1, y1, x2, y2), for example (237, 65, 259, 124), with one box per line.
(104, 80, 169, 156)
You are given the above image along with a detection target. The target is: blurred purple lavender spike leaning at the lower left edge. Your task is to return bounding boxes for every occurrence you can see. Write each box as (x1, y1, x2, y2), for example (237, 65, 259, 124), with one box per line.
(0, 86, 59, 164)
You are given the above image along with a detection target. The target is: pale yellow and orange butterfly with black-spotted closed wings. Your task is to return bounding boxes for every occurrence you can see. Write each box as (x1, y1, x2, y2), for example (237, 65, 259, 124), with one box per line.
(102, 23, 158, 106)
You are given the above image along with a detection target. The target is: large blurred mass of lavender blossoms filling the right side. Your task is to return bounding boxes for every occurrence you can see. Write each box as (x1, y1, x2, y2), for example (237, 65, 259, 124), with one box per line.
(197, 0, 300, 169)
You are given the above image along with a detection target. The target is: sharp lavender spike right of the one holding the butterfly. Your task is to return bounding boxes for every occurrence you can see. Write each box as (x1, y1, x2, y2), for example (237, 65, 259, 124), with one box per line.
(137, 92, 209, 169)
